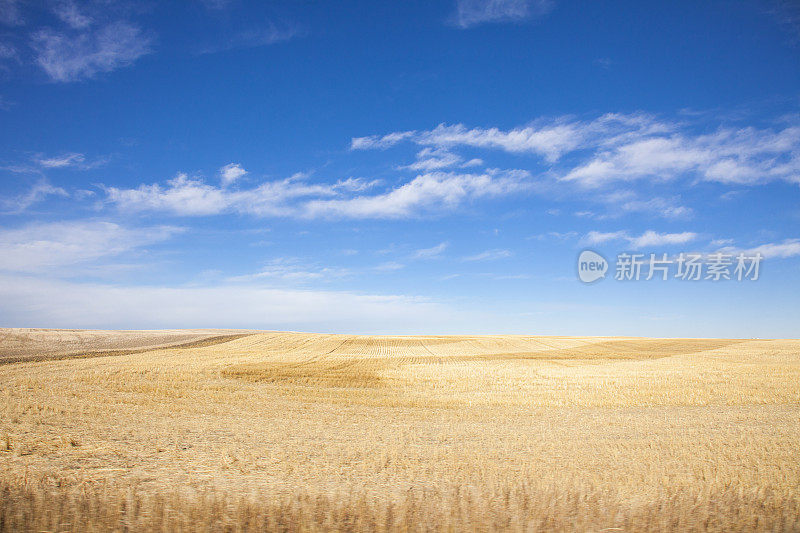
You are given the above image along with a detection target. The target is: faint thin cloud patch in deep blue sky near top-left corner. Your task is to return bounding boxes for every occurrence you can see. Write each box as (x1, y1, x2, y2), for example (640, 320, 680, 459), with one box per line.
(31, 21, 151, 82)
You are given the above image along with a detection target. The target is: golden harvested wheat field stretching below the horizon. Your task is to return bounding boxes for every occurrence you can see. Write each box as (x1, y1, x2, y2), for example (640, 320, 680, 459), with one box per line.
(0, 330, 800, 531)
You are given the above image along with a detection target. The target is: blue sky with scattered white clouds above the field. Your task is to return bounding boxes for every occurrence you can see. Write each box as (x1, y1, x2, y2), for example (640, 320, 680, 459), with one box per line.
(0, 0, 800, 337)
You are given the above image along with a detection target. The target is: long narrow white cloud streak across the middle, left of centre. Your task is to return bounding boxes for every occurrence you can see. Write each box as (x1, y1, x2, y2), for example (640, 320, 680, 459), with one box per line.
(106, 171, 529, 218)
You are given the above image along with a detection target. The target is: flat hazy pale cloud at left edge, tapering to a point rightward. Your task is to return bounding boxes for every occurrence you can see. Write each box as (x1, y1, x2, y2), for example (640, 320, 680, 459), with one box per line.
(0, 221, 181, 272)
